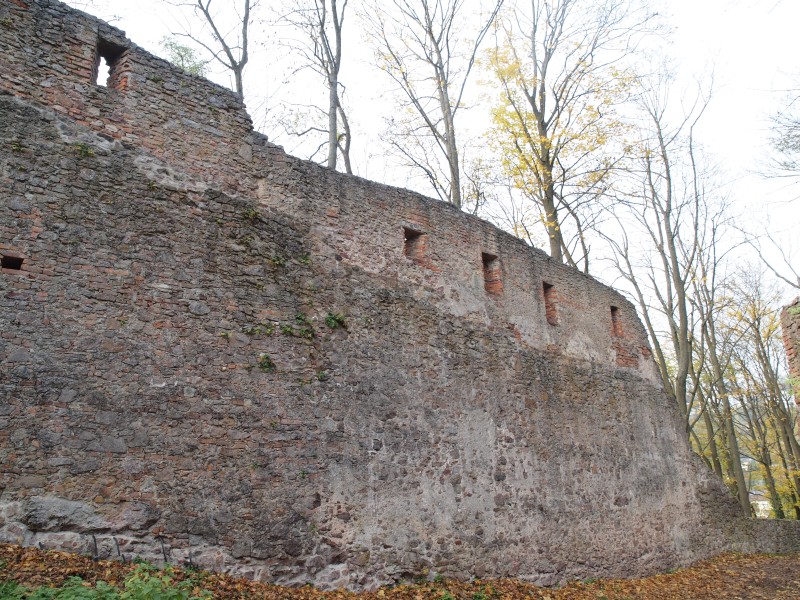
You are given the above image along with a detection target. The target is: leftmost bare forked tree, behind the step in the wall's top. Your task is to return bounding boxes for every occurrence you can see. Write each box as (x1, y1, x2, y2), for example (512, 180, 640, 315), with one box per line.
(168, 0, 259, 98)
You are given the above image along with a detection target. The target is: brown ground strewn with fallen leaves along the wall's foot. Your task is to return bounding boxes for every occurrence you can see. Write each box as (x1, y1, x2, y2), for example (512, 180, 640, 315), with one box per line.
(0, 544, 800, 600)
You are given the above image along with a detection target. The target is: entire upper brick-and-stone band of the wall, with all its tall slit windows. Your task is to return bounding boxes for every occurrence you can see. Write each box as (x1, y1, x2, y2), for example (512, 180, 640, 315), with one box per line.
(0, 3, 657, 381)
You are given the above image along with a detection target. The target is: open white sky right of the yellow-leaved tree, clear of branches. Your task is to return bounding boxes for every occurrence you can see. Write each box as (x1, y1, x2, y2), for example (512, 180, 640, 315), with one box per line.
(665, 0, 800, 299)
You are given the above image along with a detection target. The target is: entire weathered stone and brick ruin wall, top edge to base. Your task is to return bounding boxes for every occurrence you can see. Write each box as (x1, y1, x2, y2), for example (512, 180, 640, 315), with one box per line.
(0, 0, 800, 587)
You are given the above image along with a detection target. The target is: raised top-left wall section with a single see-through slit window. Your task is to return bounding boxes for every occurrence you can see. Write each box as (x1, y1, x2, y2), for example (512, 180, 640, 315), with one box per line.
(0, 0, 252, 189)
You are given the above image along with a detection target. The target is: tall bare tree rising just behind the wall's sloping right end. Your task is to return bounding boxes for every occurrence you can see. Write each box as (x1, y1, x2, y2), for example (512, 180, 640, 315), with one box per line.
(607, 74, 707, 415)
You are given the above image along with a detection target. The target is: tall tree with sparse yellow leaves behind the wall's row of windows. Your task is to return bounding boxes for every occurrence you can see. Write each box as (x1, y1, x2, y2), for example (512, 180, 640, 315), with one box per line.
(490, 0, 653, 270)
